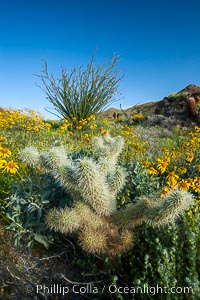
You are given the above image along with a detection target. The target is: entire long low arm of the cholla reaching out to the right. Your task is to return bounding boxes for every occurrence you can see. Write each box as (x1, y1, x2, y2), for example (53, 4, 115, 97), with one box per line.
(112, 190, 194, 229)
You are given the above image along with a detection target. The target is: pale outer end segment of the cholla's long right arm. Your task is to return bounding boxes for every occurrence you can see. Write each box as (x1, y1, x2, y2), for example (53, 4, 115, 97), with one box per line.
(145, 189, 194, 227)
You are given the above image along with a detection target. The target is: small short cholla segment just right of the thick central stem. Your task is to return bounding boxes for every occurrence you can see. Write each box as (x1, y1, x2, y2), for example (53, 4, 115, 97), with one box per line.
(107, 166, 126, 195)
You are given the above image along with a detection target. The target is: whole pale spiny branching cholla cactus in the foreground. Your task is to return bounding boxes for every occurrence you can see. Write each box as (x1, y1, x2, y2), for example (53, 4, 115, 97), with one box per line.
(23, 134, 194, 256)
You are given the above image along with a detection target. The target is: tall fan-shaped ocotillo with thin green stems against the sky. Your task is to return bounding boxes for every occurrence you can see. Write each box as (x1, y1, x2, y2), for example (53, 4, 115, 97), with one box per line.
(38, 55, 121, 122)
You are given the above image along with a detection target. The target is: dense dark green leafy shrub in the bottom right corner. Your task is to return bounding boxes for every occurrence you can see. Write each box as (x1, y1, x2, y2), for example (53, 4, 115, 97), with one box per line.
(116, 206, 200, 300)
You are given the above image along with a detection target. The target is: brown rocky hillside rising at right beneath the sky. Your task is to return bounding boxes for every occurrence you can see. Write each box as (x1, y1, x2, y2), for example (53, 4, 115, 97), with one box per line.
(103, 84, 200, 125)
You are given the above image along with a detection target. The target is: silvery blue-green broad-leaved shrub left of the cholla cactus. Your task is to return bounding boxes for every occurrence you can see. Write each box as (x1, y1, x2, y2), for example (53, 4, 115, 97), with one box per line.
(3, 170, 71, 251)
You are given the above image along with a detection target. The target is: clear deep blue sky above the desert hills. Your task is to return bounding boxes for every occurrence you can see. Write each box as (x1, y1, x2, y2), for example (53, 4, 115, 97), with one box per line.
(0, 0, 200, 119)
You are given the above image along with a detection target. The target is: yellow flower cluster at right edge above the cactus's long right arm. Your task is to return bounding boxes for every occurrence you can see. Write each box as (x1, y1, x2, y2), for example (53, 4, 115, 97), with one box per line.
(143, 126, 200, 195)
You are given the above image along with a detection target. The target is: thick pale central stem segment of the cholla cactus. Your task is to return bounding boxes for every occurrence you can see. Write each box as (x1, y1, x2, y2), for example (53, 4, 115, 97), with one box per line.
(73, 158, 116, 216)
